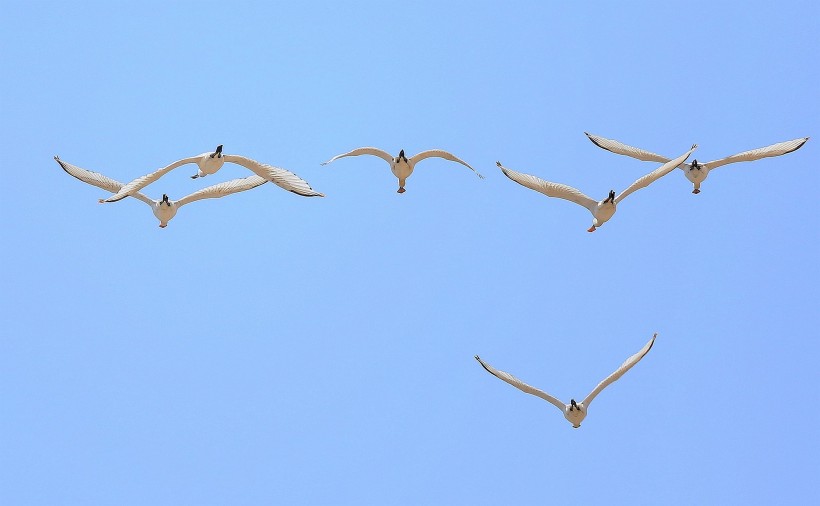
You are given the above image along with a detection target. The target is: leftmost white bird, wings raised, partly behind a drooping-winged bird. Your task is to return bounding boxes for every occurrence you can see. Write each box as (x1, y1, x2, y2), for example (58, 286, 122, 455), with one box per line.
(54, 156, 268, 228)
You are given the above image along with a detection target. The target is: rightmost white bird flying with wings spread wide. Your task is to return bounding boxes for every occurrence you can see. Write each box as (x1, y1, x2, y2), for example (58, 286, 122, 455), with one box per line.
(584, 132, 809, 194)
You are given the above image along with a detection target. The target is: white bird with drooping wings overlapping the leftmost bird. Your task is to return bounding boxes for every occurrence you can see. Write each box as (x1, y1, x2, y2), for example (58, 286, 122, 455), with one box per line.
(103, 144, 324, 202)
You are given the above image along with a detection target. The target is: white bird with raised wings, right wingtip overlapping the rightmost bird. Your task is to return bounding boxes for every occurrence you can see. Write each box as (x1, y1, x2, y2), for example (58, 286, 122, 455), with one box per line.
(496, 144, 697, 232)
